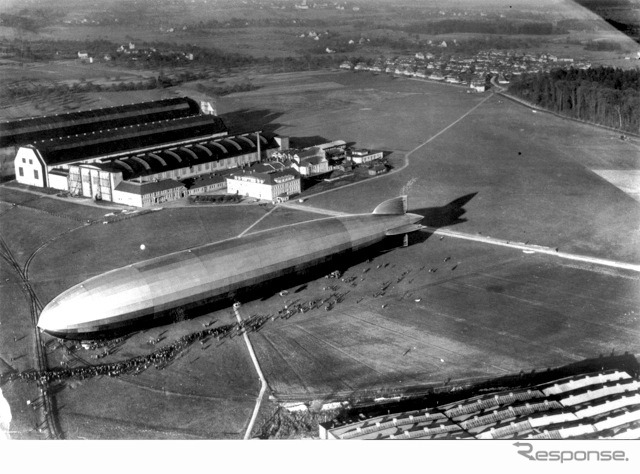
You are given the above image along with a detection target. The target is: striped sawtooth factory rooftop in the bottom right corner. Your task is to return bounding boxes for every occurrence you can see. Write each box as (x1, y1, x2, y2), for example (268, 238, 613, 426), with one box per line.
(320, 370, 640, 439)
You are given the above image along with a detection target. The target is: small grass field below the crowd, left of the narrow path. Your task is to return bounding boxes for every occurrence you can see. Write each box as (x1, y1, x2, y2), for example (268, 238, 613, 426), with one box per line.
(57, 336, 259, 439)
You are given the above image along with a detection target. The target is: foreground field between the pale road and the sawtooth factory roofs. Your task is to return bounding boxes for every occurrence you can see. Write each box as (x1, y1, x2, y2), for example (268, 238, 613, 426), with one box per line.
(246, 237, 640, 400)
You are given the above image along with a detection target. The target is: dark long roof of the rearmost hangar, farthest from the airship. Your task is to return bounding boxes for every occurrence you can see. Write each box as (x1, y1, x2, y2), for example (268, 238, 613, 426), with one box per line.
(0, 97, 200, 147)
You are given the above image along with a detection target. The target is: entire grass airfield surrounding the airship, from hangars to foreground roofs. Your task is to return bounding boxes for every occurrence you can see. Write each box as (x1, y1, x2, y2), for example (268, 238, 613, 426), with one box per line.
(0, 73, 640, 439)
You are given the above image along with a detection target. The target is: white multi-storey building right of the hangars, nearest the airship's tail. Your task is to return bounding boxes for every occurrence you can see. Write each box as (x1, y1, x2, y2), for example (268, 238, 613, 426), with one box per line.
(227, 164, 302, 202)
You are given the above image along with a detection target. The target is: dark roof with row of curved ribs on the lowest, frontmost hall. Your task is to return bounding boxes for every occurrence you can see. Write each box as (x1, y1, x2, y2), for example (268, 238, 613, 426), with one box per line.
(91, 134, 278, 180)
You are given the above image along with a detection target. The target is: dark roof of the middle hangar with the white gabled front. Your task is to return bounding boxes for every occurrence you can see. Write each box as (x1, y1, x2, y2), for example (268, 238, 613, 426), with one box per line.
(31, 115, 227, 166)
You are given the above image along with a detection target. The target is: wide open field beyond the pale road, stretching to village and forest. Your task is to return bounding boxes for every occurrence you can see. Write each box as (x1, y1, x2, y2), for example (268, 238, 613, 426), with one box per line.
(220, 73, 640, 263)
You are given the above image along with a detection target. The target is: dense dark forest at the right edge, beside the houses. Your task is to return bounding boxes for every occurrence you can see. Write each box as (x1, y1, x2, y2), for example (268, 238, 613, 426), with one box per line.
(509, 67, 640, 133)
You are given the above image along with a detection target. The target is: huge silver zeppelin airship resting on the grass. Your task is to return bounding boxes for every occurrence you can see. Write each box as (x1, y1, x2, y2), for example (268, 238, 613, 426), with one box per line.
(38, 196, 423, 339)
